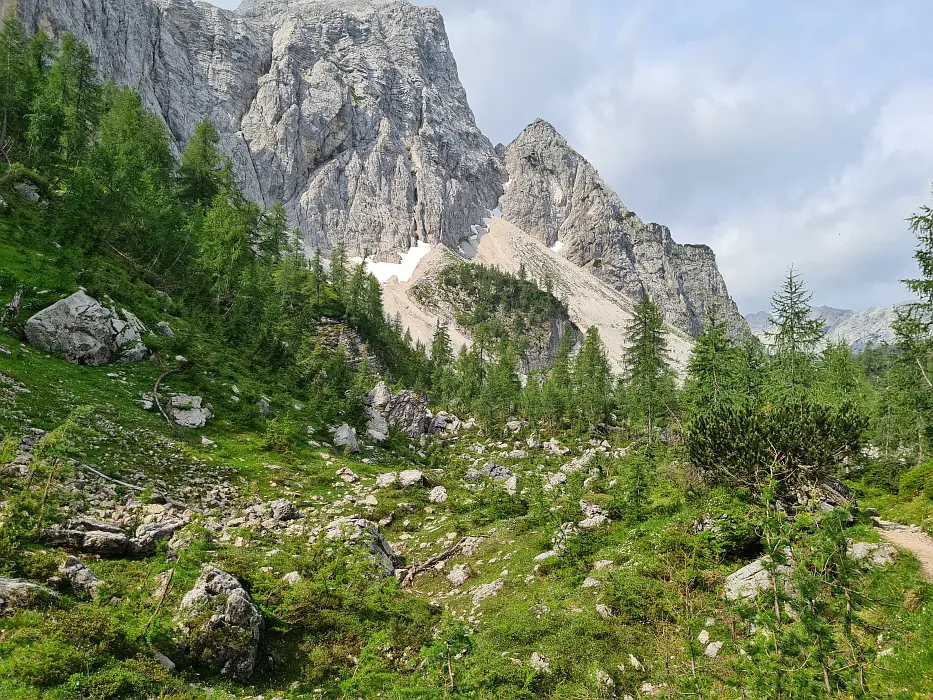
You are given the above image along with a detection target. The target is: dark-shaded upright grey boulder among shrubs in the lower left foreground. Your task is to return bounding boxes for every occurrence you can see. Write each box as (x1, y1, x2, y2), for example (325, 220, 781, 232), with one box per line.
(177, 564, 263, 681)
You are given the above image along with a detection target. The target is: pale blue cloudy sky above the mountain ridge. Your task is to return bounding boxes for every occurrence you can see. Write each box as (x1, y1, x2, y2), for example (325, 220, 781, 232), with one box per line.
(209, 0, 933, 313)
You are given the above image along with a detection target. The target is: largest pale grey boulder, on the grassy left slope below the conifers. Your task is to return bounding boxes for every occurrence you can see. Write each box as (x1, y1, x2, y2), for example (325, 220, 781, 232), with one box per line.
(24, 291, 149, 366)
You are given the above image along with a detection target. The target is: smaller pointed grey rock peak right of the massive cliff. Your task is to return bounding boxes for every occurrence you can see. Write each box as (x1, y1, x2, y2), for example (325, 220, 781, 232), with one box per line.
(501, 120, 747, 333)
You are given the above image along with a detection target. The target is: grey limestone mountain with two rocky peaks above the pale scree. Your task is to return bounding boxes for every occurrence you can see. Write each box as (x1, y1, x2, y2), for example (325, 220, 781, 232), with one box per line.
(0, 0, 746, 342)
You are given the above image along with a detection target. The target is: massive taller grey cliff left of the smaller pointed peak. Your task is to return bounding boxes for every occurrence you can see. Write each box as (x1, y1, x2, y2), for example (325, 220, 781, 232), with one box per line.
(7, 0, 504, 260)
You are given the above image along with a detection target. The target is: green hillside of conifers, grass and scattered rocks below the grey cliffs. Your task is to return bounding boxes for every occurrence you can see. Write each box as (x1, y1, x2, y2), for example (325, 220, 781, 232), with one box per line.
(0, 20, 933, 700)
